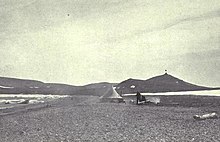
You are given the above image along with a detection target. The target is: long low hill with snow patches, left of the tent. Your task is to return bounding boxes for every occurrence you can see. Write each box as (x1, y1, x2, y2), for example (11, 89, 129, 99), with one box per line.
(0, 77, 114, 96)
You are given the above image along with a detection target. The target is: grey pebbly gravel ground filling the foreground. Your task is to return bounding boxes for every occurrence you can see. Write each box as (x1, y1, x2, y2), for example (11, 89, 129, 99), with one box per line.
(0, 96, 220, 142)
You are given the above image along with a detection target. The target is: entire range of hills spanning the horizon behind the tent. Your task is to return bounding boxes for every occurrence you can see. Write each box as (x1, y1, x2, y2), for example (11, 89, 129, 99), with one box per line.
(0, 73, 220, 96)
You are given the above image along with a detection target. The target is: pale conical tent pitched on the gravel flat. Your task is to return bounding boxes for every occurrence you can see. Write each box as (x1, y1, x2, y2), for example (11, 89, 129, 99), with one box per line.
(100, 87, 124, 102)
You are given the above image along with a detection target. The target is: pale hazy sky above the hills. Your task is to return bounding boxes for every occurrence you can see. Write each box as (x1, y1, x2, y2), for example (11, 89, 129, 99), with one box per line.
(0, 0, 220, 87)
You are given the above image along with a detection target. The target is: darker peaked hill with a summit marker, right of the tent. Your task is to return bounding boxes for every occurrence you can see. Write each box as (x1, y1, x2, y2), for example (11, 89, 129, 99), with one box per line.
(116, 73, 217, 94)
